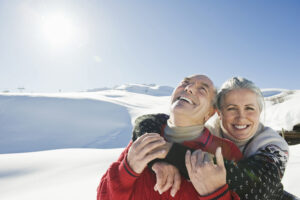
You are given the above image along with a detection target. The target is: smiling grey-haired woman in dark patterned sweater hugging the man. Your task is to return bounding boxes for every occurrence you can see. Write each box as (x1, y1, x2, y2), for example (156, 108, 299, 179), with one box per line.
(134, 77, 292, 199)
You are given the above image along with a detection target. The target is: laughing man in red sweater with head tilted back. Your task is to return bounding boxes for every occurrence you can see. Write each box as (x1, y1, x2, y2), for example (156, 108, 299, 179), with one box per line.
(97, 75, 241, 200)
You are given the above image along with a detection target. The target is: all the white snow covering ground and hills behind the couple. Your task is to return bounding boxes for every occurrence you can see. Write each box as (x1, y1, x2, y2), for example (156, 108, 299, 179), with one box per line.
(0, 84, 300, 200)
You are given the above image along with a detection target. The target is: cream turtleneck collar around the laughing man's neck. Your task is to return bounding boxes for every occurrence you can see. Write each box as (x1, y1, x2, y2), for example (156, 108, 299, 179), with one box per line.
(164, 120, 204, 143)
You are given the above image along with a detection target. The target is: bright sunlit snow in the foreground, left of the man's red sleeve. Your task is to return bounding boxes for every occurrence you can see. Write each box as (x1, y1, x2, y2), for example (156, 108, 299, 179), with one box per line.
(0, 149, 122, 200)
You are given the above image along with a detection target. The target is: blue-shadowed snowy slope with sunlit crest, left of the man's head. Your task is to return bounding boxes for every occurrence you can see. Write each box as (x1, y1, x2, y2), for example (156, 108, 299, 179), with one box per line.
(0, 90, 169, 153)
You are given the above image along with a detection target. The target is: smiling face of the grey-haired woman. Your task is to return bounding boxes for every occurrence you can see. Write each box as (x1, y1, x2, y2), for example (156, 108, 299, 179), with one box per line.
(218, 89, 261, 140)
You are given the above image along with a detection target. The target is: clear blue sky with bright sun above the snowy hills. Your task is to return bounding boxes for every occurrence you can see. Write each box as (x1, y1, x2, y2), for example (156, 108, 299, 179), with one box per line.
(0, 0, 300, 92)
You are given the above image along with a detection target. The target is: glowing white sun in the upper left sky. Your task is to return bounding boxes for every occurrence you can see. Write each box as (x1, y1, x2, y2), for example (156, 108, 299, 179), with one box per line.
(42, 13, 78, 48)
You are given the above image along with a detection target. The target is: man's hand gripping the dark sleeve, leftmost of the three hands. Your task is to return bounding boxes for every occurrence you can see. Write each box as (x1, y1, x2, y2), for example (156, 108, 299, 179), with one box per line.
(127, 133, 166, 174)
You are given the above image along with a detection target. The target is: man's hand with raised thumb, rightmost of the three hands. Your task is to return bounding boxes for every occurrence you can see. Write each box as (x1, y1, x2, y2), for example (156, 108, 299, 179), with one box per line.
(185, 147, 226, 196)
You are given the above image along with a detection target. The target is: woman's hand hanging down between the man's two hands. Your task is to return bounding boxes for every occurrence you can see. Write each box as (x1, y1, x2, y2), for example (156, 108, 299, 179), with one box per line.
(152, 162, 181, 197)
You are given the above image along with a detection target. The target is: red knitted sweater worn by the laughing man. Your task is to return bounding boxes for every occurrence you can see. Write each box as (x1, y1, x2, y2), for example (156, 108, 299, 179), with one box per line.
(97, 129, 242, 200)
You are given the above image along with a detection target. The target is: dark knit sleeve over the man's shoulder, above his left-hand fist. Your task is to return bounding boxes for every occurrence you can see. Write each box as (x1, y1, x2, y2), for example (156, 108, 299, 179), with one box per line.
(132, 113, 169, 141)
